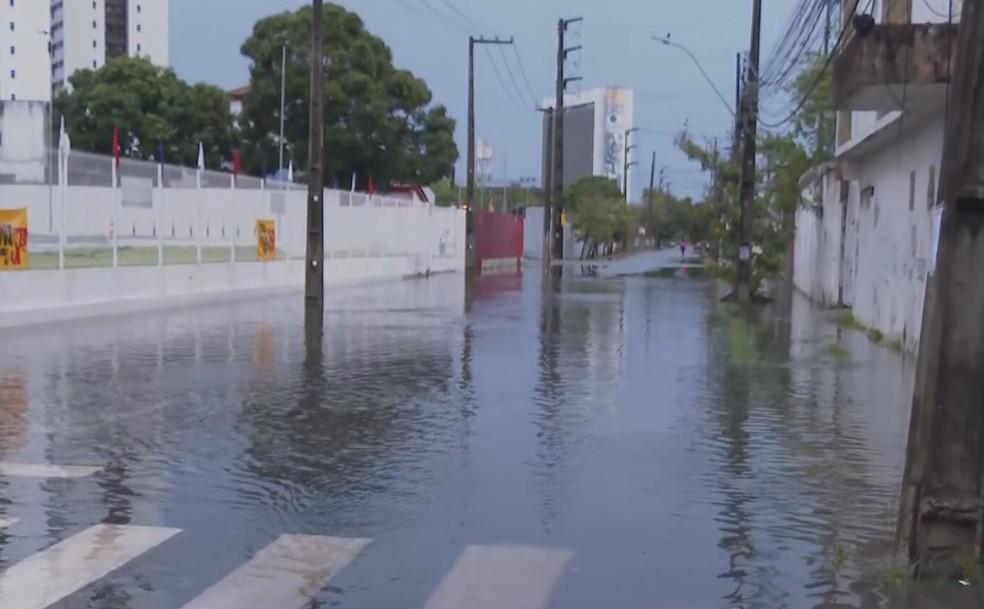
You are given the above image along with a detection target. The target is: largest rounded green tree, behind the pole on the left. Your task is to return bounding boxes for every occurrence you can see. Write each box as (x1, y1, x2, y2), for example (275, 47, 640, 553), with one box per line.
(240, 4, 458, 186)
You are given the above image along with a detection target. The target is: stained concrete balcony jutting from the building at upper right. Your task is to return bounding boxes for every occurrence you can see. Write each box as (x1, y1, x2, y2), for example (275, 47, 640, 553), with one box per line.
(833, 23, 958, 112)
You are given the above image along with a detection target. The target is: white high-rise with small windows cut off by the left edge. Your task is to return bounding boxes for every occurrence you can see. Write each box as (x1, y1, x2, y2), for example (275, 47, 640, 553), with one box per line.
(0, 0, 51, 102)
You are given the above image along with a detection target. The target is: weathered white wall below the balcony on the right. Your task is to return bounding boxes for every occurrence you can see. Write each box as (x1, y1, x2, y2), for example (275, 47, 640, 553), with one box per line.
(793, 116, 943, 349)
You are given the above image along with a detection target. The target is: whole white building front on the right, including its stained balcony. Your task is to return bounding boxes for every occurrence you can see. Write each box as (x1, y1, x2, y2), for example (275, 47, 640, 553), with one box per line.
(794, 0, 960, 349)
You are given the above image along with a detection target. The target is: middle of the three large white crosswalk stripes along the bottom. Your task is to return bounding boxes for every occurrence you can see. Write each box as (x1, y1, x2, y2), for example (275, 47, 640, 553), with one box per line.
(177, 535, 371, 609)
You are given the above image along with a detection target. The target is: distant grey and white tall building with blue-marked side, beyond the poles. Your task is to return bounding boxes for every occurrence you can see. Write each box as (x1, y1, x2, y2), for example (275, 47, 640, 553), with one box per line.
(543, 87, 633, 198)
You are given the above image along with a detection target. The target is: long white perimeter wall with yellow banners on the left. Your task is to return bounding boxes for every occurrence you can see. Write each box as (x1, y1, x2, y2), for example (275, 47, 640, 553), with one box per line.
(0, 185, 466, 325)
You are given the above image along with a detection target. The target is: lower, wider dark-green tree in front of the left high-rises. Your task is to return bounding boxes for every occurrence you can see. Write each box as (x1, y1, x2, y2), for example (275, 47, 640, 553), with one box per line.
(55, 57, 235, 167)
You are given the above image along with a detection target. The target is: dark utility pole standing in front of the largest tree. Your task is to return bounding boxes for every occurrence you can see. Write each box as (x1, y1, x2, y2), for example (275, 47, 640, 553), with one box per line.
(304, 0, 325, 305)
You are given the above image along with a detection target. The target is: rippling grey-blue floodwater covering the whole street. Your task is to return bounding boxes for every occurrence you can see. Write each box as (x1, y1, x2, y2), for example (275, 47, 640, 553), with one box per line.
(0, 249, 976, 609)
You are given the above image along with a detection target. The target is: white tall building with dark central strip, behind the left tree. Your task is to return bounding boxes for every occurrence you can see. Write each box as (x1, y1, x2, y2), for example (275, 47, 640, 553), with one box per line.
(50, 0, 170, 90)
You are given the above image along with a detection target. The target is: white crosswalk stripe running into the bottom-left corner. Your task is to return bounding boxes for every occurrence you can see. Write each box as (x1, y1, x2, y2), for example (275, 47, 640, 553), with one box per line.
(0, 525, 179, 609)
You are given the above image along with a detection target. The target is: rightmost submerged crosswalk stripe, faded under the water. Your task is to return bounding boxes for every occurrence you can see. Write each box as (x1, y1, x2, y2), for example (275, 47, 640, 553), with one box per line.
(426, 546, 572, 609)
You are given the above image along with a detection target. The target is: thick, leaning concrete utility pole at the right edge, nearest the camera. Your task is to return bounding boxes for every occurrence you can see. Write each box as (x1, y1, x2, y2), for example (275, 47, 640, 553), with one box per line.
(898, 0, 984, 575)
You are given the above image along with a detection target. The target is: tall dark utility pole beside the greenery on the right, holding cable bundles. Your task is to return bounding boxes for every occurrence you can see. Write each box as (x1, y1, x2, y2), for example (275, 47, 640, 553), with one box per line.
(735, 0, 762, 304)
